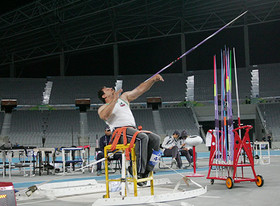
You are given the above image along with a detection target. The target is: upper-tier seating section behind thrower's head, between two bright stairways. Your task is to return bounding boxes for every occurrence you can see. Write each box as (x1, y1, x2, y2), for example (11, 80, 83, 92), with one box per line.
(49, 74, 186, 104)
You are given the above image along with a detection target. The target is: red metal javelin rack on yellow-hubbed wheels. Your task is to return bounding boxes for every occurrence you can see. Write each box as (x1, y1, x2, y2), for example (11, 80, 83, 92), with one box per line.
(207, 125, 264, 189)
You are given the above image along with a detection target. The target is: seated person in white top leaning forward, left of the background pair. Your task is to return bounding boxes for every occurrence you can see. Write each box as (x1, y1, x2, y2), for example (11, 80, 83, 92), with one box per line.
(162, 130, 182, 168)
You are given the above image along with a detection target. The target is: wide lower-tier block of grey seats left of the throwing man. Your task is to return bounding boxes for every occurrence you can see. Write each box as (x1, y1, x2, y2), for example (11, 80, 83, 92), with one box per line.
(9, 110, 79, 147)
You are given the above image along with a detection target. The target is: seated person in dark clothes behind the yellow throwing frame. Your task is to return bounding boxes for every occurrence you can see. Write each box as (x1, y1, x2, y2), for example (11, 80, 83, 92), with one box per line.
(96, 126, 122, 176)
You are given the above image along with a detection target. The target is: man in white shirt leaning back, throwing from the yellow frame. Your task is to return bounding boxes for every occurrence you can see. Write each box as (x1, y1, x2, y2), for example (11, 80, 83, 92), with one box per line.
(98, 74, 164, 180)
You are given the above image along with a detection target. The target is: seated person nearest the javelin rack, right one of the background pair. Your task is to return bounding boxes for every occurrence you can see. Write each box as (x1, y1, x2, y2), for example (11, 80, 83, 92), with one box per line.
(177, 130, 193, 166)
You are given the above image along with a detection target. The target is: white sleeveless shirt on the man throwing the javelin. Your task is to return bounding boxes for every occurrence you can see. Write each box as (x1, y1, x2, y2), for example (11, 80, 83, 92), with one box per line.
(106, 98, 136, 131)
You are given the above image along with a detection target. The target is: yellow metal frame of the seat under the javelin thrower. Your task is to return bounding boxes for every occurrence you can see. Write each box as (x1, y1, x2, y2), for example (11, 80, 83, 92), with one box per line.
(104, 144, 154, 198)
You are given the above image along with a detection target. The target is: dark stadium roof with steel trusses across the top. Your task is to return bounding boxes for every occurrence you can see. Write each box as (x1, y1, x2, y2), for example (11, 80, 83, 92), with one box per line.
(0, 0, 280, 66)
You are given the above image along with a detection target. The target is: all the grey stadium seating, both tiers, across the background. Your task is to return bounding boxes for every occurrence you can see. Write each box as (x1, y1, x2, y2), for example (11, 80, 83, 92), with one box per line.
(3, 64, 280, 147)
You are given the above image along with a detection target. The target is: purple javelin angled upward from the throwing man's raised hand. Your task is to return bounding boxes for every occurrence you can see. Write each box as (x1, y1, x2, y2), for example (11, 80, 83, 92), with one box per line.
(146, 11, 248, 81)
